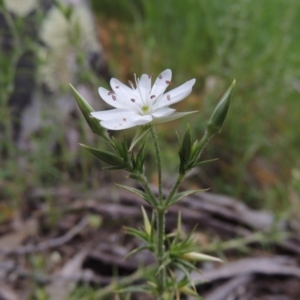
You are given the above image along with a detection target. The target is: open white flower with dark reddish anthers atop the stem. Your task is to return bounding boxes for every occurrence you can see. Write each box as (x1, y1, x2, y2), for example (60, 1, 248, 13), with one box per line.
(91, 69, 196, 130)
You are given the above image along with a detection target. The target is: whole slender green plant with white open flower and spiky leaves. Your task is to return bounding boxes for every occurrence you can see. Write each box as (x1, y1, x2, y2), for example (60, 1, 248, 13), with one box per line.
(71, 69, 235, 300)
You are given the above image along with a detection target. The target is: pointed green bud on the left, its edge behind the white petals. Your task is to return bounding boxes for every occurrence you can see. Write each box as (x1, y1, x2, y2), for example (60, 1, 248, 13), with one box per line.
(70, 84, 111, 142)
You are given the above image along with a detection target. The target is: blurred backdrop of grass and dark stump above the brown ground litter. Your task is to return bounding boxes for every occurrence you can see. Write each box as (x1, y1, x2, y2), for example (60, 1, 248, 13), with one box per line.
(0, 0, 300, 298)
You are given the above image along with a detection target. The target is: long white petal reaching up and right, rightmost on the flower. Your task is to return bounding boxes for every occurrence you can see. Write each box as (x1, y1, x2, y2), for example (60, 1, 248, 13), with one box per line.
(153, 79, 196, 109)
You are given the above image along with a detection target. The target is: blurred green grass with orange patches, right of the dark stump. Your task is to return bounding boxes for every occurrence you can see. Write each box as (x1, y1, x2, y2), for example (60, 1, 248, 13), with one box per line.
(93, 0, 300, 210)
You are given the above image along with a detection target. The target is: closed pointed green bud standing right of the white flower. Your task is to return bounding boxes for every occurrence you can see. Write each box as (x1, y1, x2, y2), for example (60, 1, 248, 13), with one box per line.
(207, 80, 235, 136)
